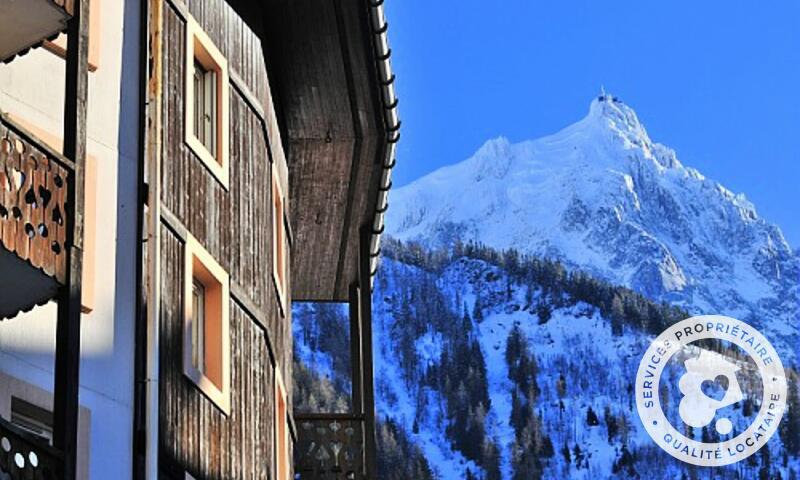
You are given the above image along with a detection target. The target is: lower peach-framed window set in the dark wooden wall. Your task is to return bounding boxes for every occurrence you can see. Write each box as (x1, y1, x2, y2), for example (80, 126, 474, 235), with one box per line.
(183, 232, 230, 414)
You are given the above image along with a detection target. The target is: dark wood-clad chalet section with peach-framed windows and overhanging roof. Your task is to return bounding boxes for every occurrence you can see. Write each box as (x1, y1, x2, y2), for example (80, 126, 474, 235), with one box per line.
(135, 0, 399, 480)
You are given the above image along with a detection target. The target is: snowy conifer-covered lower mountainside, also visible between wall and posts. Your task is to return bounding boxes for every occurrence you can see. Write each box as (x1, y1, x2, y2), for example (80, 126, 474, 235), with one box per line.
(293, 239, 800, 480)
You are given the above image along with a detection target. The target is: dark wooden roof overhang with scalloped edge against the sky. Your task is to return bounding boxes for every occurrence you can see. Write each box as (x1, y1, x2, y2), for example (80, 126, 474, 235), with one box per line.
(264, 0, 400, 301)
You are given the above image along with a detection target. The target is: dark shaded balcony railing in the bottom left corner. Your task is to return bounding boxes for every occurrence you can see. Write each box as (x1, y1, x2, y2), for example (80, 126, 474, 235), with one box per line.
(0, 418, 62, 480)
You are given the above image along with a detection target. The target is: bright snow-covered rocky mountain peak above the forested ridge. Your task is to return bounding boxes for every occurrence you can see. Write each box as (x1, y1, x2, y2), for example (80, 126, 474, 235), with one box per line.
(387, 95, 800, 358)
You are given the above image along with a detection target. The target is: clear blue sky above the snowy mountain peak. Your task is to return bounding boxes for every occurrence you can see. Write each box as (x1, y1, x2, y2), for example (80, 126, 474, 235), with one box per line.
(386, 0, 800, 247)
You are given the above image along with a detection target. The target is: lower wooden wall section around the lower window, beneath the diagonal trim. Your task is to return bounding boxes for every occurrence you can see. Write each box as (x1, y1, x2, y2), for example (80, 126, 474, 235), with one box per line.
(159, 226, 274, 480)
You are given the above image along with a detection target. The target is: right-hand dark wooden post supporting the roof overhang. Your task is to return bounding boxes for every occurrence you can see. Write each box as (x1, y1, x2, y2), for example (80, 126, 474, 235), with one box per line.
(358, 226, 377, 478)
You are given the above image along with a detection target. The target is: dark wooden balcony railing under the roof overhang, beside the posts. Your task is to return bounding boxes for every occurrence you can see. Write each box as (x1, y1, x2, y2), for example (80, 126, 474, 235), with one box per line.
(294, 414, 366, 480)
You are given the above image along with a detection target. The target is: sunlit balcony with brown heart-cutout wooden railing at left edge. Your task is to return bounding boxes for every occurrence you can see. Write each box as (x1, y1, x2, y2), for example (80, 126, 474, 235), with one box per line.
(0, 113, 73, 319)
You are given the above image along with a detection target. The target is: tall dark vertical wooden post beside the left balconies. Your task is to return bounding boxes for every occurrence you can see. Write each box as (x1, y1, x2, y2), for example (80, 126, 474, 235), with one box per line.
(53, 0, 89, 480)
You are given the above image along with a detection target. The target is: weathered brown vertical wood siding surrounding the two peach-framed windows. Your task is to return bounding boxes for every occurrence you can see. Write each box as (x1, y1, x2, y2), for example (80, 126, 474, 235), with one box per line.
(160, 0, 292, 480)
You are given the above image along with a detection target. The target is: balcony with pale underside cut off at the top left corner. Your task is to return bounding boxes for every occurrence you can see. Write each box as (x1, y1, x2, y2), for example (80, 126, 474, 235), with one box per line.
(0, 0, 74, 62)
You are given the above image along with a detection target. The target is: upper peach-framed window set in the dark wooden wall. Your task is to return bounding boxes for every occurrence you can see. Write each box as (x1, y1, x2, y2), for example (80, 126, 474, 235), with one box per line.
(185, 18, 229, 188)
